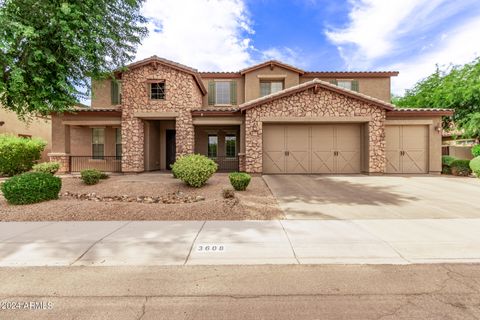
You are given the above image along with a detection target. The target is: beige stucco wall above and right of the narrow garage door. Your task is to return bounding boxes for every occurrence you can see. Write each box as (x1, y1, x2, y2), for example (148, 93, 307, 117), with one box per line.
(387, 113, 442, 174)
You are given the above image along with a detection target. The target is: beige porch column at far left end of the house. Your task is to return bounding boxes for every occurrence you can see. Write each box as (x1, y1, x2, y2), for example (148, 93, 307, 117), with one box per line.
(48, 114, 70, 173)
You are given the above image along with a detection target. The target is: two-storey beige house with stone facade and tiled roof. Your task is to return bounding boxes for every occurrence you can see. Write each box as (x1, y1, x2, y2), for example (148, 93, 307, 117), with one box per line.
(50, 56, 452, 174)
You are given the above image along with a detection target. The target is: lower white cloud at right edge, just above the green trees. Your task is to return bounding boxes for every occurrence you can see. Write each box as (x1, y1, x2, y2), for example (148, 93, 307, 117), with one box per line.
(383, 18, 480, 94)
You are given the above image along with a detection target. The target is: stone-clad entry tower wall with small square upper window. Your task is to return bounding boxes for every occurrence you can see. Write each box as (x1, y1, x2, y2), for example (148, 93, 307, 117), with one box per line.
(122, 64, 202, 172)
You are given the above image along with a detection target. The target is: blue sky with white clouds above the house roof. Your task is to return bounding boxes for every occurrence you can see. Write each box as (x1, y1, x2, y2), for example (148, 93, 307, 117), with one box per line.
(137, 0, 480, 94)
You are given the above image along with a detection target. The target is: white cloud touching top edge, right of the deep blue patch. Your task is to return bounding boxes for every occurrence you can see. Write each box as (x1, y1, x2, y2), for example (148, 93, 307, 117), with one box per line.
(326, 0, 473, 68)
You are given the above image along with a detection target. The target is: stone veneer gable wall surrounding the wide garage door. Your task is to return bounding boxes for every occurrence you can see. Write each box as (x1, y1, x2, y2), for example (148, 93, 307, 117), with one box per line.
(245, 89, 386, 173)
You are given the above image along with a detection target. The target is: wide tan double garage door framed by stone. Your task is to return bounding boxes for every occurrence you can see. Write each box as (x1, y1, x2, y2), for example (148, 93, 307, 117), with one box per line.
(263, 124, 361, 174)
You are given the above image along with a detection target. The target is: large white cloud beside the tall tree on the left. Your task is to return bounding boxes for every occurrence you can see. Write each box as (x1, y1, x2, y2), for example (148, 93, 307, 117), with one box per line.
(136, 0, 253, 71)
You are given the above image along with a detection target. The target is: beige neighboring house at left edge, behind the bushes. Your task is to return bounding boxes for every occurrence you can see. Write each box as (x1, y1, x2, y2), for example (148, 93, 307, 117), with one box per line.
(0, 106, 52, 161)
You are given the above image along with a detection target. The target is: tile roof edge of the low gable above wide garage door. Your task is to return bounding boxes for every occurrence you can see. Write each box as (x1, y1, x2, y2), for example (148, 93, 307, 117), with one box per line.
(240, 79, 395, 110)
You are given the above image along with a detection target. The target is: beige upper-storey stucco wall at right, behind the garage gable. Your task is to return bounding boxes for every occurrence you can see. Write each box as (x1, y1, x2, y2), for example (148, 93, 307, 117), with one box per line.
(300, 76, 391, 102)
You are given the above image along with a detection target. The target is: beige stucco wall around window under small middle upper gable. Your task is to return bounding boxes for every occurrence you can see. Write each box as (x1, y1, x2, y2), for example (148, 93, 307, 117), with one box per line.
(245, 66, 299, 101)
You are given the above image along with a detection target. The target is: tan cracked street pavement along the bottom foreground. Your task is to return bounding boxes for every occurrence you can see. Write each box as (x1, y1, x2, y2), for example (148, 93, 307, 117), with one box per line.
(0, 264, 480, 320)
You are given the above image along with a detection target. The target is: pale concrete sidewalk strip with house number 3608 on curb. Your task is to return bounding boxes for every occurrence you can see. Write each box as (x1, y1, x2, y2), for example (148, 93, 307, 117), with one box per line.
(0, 219, 480, 266)
